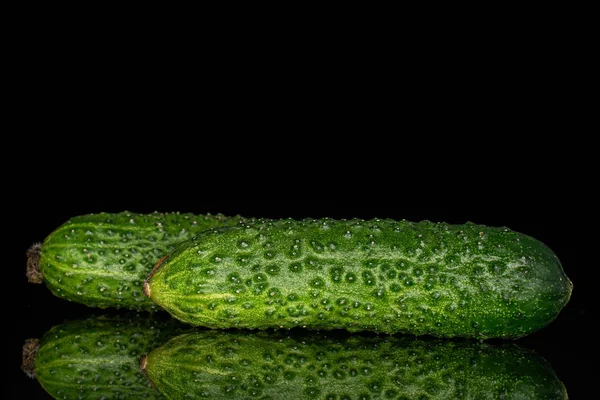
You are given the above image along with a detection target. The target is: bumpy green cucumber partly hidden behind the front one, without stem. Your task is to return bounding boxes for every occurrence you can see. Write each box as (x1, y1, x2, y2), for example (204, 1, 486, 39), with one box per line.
(40, 212, 241, 310)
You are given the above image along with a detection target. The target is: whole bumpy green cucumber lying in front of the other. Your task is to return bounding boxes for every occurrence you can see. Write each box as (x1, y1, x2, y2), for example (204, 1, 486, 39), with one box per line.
(146, 219, 572, 339)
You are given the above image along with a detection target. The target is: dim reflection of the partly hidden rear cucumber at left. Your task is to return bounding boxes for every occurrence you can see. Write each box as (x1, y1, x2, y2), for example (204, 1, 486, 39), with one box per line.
(22, 313, 186, 400)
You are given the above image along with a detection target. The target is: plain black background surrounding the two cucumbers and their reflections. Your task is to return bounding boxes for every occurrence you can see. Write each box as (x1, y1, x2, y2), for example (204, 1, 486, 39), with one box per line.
(0, 8, 598, 399)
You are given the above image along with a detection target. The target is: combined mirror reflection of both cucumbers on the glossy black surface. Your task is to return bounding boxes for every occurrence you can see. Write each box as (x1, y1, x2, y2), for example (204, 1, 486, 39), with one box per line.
(24, 313, 567, 400)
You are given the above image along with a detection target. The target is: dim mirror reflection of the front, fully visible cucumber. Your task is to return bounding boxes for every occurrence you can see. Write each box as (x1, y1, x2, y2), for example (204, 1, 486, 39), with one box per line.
(142, 330, 567, 400)
